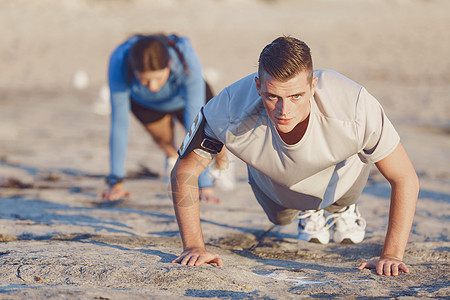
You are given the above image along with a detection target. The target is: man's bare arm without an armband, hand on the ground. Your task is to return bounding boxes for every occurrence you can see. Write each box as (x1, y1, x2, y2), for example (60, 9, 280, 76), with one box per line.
(359, 143, 419, 276)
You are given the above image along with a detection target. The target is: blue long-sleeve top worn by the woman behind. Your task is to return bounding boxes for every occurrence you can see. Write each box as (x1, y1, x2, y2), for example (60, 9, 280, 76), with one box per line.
(108, 36, 212, 188)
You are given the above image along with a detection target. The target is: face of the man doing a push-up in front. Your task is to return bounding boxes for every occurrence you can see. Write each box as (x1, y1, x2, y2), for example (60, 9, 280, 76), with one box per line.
(255, 72, 317, 134)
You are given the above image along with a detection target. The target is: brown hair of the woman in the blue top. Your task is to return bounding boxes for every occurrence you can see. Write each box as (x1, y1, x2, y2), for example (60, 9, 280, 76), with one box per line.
(128, 34, 189, 74)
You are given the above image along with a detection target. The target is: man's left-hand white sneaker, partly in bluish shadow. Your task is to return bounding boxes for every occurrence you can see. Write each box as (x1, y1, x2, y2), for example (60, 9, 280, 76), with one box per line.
(298, 209, 330, 244)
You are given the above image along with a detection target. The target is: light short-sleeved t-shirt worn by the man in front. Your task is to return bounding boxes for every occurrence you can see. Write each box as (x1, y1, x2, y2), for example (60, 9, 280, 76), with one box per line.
(204, 70, 400, 210)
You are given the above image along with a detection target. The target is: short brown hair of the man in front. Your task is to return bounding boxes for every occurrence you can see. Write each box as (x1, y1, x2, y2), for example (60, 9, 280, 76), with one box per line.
(258, 36, 313, 82)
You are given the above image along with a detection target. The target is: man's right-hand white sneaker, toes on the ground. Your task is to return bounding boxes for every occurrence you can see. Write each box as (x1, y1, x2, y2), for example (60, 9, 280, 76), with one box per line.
(327, 204, 366, 244)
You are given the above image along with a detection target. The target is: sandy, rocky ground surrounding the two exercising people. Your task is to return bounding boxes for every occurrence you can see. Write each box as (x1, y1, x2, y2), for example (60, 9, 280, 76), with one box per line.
(0, 0, 450, 299)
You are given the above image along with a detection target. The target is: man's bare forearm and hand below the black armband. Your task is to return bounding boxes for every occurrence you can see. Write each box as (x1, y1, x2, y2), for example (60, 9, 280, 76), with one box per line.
(171, 152, 222, 266)
